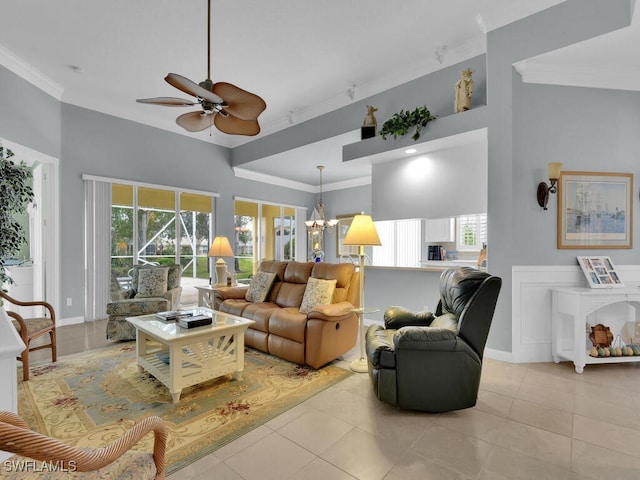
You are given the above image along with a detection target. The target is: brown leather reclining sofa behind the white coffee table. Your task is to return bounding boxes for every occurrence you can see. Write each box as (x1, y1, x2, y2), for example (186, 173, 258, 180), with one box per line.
(214, 261, 360, 368)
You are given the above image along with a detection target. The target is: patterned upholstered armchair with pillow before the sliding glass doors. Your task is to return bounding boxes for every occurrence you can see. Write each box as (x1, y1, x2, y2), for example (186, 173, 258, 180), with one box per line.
(107, 265, 182, 340)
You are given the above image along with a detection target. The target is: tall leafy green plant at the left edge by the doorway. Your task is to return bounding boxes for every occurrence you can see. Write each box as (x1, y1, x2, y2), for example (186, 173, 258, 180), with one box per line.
(0, 144, 33, 287)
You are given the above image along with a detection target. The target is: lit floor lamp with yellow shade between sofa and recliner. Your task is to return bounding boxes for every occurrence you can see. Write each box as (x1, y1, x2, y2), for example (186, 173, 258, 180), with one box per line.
(343, 213, 382, 373)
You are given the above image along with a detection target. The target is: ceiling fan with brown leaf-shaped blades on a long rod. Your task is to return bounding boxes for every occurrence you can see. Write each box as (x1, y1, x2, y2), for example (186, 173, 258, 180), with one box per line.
(136, 0, 267, 136)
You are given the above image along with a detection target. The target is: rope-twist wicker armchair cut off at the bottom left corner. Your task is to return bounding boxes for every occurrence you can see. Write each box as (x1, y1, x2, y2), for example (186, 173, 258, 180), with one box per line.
(0, 411, 167, 480)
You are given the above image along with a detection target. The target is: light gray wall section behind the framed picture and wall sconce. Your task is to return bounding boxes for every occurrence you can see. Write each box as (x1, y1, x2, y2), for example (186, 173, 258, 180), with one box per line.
(513, 82, 640, 265)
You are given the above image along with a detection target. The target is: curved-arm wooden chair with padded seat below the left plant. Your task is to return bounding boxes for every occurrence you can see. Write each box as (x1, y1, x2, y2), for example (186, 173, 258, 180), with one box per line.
(0, 290, 57, 382)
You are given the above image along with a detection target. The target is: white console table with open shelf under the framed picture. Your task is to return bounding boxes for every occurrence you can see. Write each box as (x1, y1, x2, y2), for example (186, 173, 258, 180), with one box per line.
(551, 286, 640, 373)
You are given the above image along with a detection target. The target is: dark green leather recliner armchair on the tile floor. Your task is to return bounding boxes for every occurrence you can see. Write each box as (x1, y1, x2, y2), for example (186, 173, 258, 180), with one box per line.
(366, 267, 502, 412)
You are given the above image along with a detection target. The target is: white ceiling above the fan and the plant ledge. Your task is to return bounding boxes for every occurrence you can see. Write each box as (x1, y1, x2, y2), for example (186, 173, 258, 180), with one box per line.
(0, 0, 640, 185)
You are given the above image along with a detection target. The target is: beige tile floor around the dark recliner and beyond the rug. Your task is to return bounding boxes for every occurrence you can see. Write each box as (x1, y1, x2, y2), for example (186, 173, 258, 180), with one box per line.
(34, 321, 640, 480)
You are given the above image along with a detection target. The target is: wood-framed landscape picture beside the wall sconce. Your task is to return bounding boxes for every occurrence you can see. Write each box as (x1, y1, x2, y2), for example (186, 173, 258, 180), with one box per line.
(558, 172, 633, 248)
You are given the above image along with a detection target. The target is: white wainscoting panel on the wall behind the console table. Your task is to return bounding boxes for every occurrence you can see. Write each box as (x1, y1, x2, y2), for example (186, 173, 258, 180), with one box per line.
(511, 265, 640, 363)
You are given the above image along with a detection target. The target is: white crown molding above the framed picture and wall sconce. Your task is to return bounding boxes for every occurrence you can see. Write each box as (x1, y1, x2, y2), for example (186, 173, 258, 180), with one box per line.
(513, 60, 640, 91)
